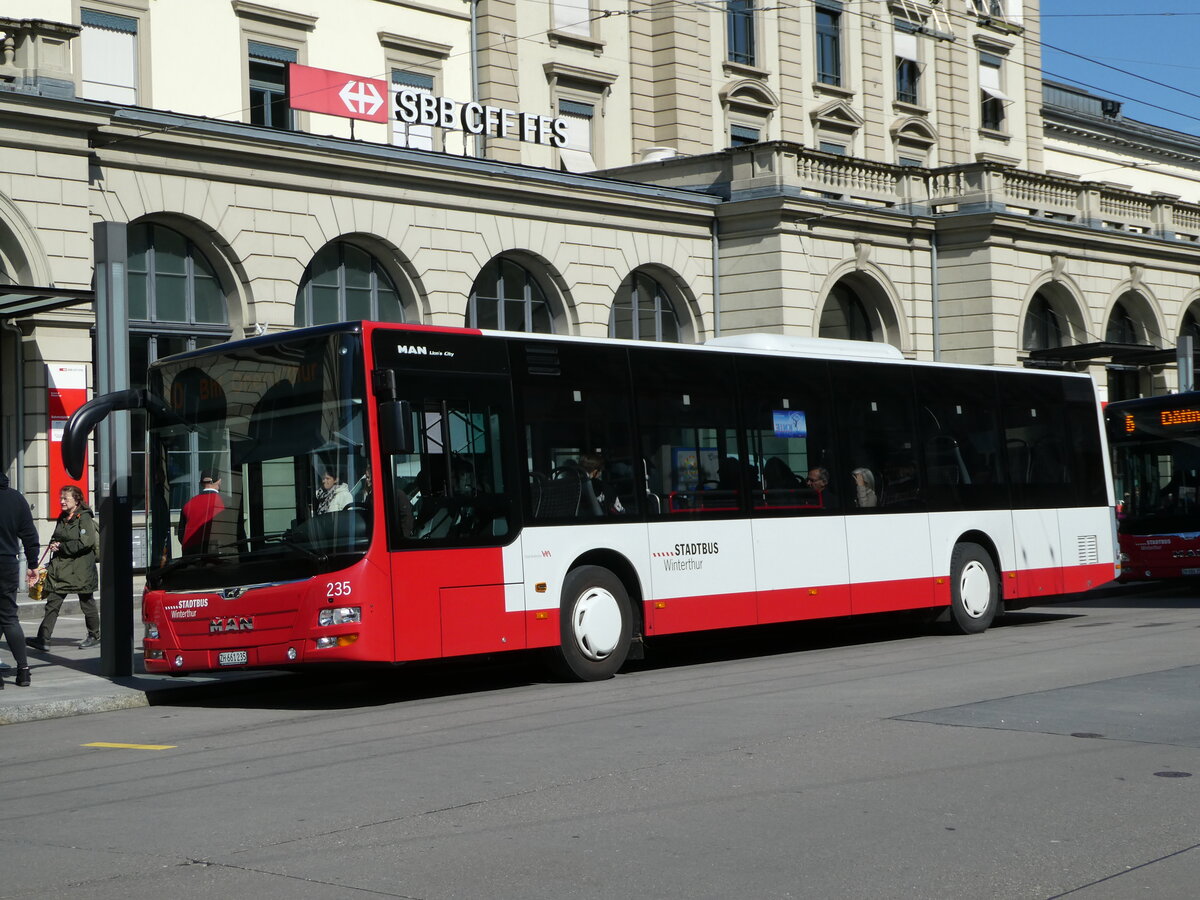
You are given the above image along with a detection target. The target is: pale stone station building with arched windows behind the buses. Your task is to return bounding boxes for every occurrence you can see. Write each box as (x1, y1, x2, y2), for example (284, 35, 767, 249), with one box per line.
(0, 0, 1200, 535)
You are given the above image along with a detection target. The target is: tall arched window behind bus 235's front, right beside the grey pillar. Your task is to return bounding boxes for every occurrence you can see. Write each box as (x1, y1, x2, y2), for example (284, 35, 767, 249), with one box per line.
(126, 222, 230, 520)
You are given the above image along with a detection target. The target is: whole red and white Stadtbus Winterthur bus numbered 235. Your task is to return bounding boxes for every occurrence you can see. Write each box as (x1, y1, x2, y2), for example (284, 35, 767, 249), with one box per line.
(63, 323, 1116, 680)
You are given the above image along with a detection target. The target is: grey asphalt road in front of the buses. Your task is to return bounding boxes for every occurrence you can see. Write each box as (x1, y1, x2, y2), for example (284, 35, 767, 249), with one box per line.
(0, 587, 1200, 900)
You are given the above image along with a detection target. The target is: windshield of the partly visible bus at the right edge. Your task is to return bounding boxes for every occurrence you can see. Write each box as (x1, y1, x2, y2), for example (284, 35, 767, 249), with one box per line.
(1114, 434, 1200, 534)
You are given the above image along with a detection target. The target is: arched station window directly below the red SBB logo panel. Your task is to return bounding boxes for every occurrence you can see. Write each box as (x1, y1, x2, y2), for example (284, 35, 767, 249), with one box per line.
(295, 241, 404, 325)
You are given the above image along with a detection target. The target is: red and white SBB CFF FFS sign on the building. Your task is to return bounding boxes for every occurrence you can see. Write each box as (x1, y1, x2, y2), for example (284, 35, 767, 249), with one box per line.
(288, 62, 568, 148)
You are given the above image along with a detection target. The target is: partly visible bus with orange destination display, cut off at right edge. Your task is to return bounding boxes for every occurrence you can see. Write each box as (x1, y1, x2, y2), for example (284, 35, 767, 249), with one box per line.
(1104, 392, 1200, 581)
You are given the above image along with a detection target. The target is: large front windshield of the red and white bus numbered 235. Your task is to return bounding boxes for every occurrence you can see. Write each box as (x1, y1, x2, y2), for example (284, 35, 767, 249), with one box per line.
(146, 331, 371, 589)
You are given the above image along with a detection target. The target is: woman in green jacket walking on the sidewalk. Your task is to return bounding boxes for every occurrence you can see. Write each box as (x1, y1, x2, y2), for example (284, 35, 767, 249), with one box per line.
(25, 485, 100, 653)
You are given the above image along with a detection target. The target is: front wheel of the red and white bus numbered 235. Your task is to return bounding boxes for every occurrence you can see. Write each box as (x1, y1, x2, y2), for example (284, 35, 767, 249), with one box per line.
(556, 565, 634, 682)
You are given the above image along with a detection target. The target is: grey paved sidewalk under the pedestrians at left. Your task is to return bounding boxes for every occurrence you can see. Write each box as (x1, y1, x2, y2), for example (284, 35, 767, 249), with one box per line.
(0, 596, 278, 725)
